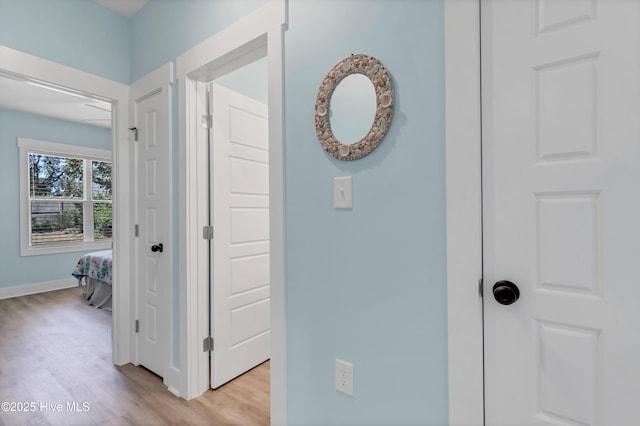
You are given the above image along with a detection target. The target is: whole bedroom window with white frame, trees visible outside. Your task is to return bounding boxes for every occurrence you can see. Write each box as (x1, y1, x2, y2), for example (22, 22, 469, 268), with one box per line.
(18, 138, 112, 256)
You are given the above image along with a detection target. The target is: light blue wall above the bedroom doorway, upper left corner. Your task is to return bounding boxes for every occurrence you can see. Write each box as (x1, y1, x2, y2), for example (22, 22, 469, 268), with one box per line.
(0, 0, 131, 83)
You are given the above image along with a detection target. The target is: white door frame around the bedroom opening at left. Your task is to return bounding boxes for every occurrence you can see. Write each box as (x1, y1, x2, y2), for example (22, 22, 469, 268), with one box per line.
(0, 46, 133, 365)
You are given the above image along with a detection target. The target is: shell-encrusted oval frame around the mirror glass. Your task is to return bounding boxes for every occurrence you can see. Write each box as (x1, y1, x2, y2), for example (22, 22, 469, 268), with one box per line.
(315, 54, 393, 160)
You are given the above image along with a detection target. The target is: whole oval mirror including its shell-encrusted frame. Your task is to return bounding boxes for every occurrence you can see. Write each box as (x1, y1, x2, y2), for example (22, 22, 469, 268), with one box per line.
(315, 54, 393, 160)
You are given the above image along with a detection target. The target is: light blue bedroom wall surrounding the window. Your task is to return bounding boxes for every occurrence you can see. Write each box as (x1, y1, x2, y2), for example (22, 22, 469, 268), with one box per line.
(0, 109, 111, 287)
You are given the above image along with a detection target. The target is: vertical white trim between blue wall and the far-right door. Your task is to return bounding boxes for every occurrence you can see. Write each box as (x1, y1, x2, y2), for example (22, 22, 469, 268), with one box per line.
(445, 0, 484, 425)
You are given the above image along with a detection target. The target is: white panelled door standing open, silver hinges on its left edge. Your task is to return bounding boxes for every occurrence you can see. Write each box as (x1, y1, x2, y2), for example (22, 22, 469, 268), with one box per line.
(210, 84, 271, 388)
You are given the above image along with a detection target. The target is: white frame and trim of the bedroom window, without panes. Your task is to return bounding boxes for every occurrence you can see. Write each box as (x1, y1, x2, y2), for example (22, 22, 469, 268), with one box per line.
(17, 138, 113, 256)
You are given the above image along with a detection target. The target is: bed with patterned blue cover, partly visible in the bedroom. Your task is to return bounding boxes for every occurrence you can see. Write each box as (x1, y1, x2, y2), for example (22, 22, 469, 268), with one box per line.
(71, 250, 112, 311)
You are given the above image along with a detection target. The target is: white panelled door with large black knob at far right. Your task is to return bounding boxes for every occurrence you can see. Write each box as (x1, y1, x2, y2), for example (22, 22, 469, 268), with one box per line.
(481, 0, 640, 426)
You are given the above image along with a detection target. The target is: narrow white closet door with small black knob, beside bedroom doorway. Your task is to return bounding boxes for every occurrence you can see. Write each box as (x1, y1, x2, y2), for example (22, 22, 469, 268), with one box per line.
(135, 92, 171, 377)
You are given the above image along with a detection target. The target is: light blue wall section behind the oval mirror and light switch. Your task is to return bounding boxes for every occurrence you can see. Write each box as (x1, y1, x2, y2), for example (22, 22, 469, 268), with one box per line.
(285, 0, 448, 426)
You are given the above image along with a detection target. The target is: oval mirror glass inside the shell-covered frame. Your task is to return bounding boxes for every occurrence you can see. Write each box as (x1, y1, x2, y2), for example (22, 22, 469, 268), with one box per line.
(329, 74, 376, 145)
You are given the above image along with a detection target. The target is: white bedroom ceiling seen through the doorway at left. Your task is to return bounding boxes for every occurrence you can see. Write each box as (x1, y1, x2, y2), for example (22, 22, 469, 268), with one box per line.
(0, 74, 111, 127)
